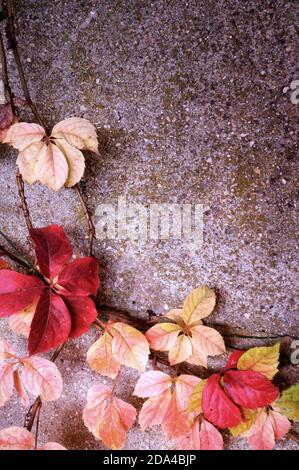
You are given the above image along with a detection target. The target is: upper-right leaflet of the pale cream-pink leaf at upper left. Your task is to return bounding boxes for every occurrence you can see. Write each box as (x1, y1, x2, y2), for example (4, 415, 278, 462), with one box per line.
(51, 117, 98, 153)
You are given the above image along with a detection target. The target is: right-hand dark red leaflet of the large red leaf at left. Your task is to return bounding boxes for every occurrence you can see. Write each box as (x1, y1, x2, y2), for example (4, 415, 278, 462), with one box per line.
(57, 258, 100, 296)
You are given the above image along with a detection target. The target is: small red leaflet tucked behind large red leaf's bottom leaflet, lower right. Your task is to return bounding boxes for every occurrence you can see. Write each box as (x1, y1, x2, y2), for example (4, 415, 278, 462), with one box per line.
(65, 296, 98, 338)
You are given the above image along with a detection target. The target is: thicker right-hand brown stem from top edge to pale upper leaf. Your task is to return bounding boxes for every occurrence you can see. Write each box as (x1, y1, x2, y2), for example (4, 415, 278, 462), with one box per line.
(6, 0, 46, 129)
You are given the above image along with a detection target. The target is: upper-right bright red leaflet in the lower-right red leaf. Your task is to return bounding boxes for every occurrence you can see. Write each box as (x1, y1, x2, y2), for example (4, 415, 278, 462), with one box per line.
(223, 370, 278, 409)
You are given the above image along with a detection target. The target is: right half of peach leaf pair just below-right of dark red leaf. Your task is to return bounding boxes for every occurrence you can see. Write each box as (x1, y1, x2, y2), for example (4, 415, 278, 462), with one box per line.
(109, 322, 150, 372)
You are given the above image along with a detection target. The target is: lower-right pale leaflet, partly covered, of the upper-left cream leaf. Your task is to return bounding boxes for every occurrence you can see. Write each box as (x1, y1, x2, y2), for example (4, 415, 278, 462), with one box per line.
(55, 139, 85, 188)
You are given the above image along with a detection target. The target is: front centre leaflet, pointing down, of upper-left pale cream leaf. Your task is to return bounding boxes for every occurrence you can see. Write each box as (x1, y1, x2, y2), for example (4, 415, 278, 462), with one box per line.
(35, 143, 68, 191)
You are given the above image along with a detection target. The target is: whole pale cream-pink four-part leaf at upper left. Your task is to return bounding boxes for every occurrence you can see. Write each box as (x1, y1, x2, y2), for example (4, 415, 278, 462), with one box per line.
(2, 118, 98, 191)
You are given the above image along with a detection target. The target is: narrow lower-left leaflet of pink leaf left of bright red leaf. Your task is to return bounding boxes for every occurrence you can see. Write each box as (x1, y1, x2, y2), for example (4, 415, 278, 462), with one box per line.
(139, 389, 171, 431)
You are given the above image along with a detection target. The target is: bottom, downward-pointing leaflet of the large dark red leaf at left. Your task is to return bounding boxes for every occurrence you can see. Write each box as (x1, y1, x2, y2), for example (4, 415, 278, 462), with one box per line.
(28, 291, 72, 355)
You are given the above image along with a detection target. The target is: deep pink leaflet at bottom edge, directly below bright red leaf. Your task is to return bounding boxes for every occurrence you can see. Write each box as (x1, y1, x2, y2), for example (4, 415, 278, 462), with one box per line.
(176, 419, 223, 450)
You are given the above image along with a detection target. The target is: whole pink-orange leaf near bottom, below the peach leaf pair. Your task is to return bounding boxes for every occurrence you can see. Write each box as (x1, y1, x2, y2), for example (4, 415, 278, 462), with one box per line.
(83, 384, 136, 450)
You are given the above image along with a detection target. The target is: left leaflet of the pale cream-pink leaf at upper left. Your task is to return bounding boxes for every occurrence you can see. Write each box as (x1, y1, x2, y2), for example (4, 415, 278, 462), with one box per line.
(3, 122, 46, 150)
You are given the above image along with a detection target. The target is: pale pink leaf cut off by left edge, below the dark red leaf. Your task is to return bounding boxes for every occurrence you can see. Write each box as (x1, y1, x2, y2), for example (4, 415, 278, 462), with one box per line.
(0, 340, 62, 406)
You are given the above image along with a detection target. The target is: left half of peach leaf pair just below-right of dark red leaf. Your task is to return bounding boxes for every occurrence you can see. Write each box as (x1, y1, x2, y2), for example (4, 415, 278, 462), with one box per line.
(87, 331, 121, 379)
